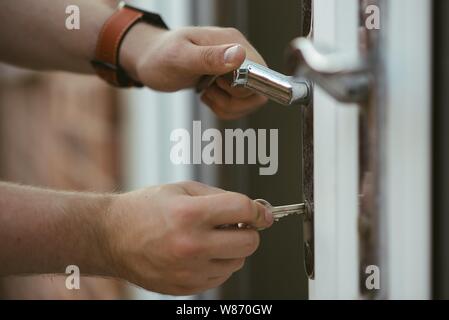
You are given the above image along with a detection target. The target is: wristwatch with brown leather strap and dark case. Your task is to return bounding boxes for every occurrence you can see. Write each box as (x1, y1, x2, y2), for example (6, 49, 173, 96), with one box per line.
(91, 1, 168, 88)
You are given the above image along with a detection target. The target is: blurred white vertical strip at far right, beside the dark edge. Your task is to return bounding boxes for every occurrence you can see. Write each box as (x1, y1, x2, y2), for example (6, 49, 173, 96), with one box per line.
(383, 0, 432, 299)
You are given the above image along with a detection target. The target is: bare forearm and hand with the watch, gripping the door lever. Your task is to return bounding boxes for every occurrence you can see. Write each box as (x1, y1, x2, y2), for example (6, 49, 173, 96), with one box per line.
(0, 0, 267, 119)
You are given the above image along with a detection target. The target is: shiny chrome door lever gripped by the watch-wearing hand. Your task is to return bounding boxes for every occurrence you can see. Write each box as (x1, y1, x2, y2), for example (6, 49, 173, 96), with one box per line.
(197, 60, 311, 105)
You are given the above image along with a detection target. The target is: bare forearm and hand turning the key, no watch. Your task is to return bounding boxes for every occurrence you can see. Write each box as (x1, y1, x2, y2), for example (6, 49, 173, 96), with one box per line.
(0, 182, 273, 295)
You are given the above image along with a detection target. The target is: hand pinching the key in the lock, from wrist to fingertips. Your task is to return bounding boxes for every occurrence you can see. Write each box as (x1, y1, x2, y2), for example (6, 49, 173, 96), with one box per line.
(103, 182, 273, 295)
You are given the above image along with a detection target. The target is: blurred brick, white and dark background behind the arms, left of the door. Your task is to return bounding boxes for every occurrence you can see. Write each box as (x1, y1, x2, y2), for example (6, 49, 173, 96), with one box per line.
(0, 0, 308, 299)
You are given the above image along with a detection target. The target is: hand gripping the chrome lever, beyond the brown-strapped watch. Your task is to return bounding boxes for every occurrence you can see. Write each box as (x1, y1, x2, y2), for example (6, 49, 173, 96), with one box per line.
(120, 23, 267, 120)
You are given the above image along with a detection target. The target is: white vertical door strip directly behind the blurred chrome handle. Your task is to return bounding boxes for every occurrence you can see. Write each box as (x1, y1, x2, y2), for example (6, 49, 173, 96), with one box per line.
(309, 0, 358, 299)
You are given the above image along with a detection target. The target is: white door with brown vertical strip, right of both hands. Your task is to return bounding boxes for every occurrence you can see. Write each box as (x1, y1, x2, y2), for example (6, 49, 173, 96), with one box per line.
(309, 0, 431, 299)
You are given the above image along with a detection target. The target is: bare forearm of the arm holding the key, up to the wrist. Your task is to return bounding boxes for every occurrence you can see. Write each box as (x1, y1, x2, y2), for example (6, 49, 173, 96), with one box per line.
(0, 183, 110, 276)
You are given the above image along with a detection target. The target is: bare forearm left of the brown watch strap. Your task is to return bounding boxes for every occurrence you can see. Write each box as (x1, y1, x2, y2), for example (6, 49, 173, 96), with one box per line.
(0, 0, 118, 73)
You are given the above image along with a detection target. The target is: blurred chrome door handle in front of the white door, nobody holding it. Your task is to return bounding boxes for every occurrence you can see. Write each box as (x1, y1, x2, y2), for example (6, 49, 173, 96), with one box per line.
(288, 38, 371, 103)
